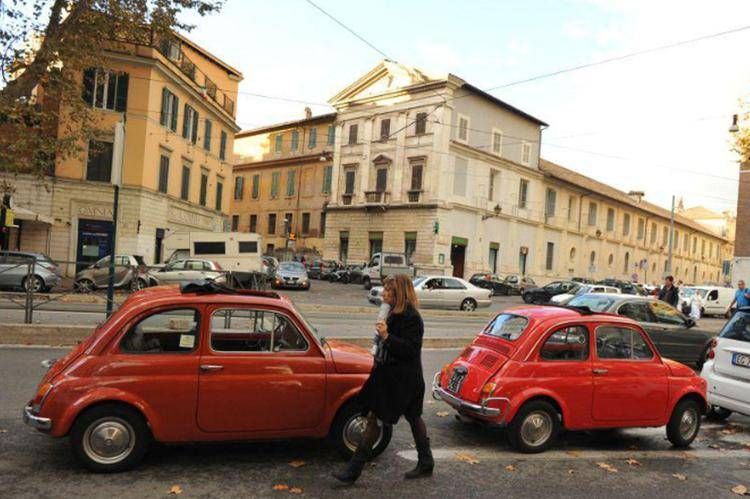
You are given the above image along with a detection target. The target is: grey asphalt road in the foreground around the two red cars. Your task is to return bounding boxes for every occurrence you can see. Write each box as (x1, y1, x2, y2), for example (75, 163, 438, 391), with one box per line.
(0, 348, 750, 499)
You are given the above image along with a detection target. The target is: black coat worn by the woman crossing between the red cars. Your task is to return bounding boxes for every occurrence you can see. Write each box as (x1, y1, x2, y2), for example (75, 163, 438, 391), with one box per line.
(358, 307, 425, 424)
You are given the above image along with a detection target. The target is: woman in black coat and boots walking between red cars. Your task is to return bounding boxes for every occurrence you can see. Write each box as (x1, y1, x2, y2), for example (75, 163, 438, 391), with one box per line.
(333, 275, 435, 483)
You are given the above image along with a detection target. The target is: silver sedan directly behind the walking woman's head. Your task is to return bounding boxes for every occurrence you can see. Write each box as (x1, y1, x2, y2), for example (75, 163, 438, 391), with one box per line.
(367, 276, 492, 312)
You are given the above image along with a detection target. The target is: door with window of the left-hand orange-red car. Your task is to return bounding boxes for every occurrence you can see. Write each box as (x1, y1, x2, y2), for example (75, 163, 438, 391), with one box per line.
(197, 305, 326, 433)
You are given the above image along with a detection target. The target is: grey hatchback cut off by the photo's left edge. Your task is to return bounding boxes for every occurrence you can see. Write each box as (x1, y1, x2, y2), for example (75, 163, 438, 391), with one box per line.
(0, 251, 61, 293)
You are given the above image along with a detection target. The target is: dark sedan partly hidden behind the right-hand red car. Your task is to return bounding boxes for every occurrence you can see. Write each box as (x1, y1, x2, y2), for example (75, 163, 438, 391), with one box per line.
(568, 294, 717, 369)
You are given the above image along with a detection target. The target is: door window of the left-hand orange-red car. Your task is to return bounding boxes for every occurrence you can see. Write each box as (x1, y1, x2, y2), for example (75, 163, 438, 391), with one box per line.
(211, 309, 307, 352)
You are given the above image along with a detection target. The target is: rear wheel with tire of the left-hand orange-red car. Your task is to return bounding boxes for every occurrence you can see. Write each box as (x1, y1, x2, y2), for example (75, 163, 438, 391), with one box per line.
(70, 404, 151, 473)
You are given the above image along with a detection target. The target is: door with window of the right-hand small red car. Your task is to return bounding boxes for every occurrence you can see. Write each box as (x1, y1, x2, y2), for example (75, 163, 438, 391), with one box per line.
(591, 324, 669, 426)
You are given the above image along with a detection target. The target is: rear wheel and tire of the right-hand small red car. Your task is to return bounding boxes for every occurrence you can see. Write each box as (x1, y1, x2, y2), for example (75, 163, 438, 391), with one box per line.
(508, 400, 561, 454)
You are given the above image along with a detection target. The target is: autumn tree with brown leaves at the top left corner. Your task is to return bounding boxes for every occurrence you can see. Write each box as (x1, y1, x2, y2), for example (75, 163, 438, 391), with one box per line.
(0, 0, 222, 186)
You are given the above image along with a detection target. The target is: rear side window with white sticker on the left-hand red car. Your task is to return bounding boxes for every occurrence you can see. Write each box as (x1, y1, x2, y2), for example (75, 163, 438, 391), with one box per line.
(120, 308, 200, 353)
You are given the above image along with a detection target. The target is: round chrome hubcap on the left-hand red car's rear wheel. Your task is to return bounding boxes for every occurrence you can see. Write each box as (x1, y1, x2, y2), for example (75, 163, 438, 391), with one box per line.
(83, 418, 135, 464)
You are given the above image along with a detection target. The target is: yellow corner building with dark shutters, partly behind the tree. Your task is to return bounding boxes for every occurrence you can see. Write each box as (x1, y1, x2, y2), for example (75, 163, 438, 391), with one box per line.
(2, 35, 242, 272)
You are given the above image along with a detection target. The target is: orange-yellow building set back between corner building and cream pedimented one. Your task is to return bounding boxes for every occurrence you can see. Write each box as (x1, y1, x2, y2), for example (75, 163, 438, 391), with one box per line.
(230, 110, 336, 253)
